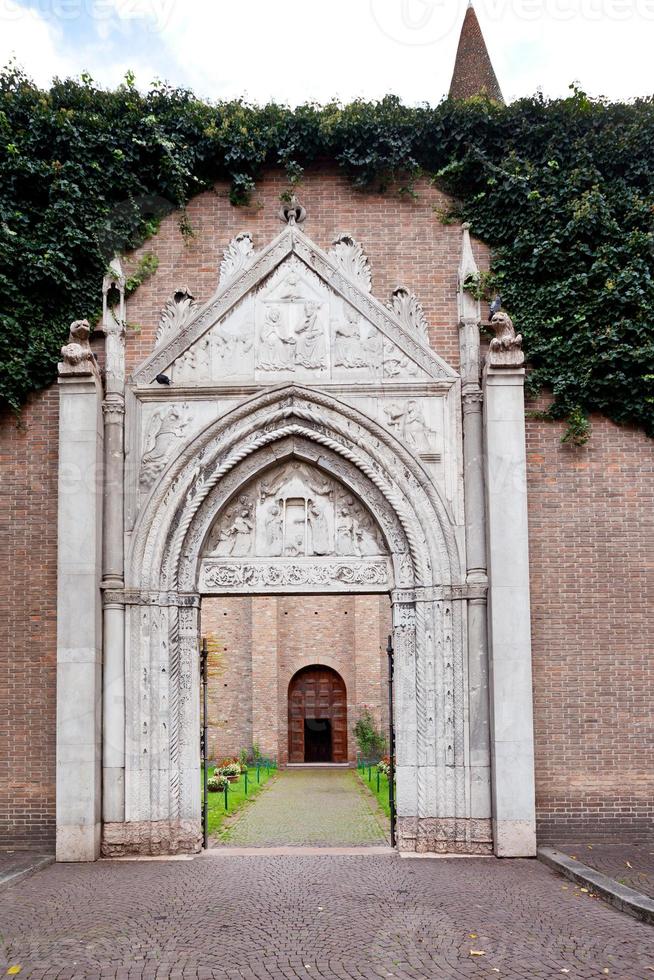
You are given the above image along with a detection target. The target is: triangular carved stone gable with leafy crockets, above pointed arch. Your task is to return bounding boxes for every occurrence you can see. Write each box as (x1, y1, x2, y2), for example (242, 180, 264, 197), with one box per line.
(134, 224, 456, 387)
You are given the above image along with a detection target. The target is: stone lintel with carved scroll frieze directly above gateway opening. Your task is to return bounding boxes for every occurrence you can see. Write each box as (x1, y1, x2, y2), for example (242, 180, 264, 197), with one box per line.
(200, 558, 391, 594)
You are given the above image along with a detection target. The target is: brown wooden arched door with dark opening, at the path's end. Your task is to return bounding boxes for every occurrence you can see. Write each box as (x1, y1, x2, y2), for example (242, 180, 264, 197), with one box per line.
(288, 664, 347, 763)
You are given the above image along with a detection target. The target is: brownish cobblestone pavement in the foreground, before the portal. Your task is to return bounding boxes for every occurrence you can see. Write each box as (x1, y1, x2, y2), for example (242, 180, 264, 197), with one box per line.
(0, 849, 654, 980)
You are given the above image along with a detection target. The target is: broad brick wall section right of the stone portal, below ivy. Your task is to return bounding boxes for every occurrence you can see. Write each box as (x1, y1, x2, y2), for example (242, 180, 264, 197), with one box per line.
(527, 400, 654, 842)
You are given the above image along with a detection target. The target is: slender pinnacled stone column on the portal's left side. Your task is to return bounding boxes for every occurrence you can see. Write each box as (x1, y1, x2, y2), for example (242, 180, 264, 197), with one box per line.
(102, 259, 125, 822)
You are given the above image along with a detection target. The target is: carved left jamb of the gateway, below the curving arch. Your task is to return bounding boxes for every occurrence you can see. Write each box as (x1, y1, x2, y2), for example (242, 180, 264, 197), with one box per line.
(102, 589, 201, 856)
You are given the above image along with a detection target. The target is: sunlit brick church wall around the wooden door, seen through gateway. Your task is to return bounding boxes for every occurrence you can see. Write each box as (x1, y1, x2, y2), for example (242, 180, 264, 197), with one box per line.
(202, 595, 391, 765)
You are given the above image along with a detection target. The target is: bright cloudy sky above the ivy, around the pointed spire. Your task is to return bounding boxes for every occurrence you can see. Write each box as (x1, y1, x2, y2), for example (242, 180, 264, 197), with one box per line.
(0, 0, 654, 104)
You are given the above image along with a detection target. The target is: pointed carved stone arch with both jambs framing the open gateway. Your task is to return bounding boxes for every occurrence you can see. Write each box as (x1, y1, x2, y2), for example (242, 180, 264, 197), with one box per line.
(107, 385, 489, 850)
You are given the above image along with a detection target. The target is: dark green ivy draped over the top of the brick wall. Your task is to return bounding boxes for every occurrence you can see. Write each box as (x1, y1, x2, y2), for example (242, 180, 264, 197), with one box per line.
(0, 67, 654, 443)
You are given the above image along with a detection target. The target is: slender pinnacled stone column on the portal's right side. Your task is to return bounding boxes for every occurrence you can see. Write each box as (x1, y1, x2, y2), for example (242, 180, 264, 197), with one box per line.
(458, 224, 491, 832)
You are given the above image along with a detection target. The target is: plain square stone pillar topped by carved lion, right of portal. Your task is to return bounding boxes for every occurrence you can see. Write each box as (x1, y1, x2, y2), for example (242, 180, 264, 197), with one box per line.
(484, 326, 536, 857)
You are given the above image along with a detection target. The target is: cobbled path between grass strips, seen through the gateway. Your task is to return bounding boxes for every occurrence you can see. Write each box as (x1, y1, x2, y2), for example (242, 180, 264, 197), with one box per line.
(216, 769, 386, 847)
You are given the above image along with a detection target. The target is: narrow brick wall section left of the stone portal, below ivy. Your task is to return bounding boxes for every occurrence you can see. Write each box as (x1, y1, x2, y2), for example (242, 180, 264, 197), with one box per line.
(0, 387, 58, 849)
